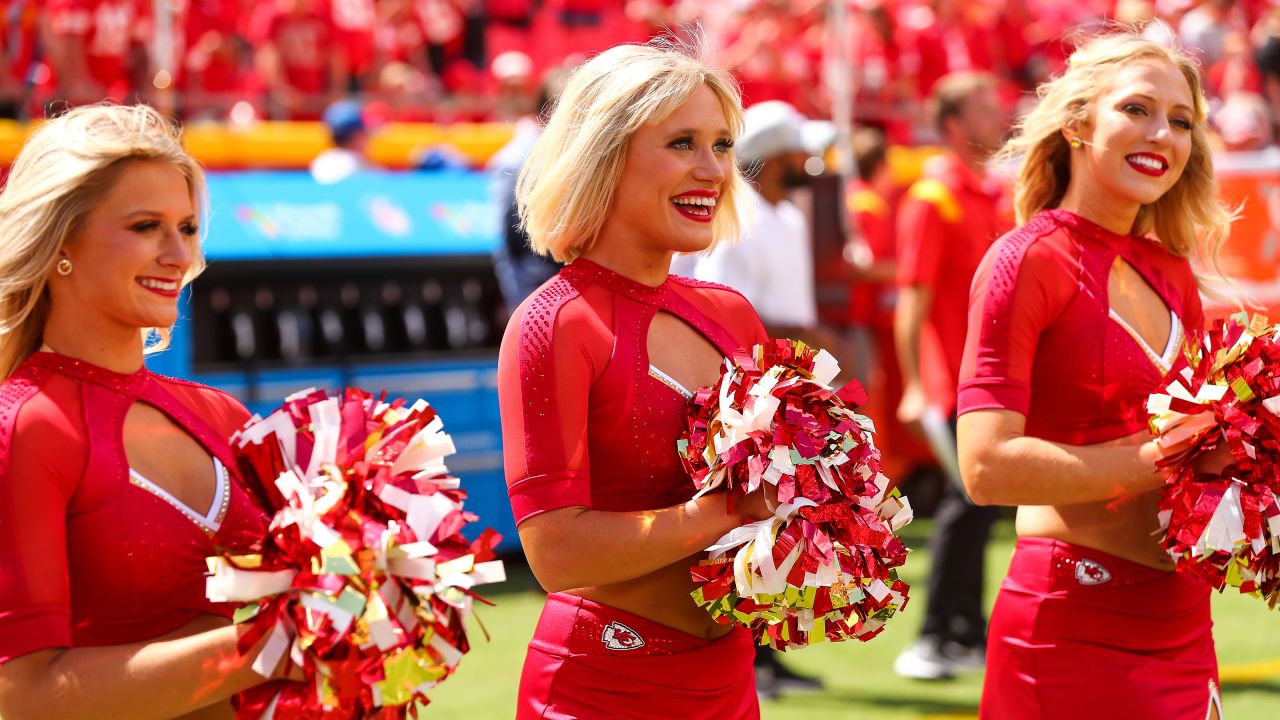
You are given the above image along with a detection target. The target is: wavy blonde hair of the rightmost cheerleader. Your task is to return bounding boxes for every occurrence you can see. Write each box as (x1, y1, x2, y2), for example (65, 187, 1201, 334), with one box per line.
(1000, 29, 1233, 261)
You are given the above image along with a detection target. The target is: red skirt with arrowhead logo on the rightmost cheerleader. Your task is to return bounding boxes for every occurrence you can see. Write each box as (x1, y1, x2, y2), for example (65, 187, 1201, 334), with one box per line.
(980, 538, 1219, 720)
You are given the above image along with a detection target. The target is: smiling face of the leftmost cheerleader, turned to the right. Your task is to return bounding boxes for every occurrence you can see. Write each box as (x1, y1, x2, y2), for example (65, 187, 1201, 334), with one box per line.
(49, 160, 198, 337)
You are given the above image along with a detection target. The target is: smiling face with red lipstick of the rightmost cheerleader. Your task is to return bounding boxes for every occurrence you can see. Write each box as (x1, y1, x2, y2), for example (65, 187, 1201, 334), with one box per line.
(1068, 60, 1196, 211)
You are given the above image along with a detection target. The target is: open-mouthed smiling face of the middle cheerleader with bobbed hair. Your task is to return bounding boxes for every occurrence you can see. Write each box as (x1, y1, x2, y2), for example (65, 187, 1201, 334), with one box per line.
(600, 86, 733, 255)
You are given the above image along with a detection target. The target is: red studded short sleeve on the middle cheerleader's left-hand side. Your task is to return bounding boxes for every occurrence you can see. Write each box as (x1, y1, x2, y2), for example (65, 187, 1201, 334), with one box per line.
(498, 279, 599, 525)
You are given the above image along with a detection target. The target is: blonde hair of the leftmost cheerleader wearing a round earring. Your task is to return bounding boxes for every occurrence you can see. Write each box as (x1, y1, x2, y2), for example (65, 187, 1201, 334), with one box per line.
(0, 105, 209, 379)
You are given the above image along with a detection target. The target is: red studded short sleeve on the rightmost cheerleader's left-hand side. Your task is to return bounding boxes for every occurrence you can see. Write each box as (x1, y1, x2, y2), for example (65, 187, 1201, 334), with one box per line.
(956, 233, 1078, 415)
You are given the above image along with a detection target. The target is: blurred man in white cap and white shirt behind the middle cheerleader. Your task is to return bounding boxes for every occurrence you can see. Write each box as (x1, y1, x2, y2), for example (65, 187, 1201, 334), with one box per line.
(672, 100, 835, 340)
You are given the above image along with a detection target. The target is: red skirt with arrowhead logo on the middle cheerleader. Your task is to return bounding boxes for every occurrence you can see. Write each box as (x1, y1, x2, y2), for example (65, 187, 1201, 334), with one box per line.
(516, 593, 760, 720)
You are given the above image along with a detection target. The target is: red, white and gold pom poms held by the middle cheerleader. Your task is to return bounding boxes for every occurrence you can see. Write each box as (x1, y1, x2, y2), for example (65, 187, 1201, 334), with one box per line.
(678, 340, 911, 650)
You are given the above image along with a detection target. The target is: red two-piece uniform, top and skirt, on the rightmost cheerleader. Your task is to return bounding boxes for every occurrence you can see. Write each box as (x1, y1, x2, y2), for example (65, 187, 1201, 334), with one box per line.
(959, 210, 1217, 720)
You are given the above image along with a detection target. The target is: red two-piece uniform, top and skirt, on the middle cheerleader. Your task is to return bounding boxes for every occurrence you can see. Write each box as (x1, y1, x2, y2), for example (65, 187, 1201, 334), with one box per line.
(498, 259, 767, 719)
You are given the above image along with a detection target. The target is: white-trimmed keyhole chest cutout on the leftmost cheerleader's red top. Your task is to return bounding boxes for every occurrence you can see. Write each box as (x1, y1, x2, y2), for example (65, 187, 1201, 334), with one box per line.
(124, 402, 222, 529)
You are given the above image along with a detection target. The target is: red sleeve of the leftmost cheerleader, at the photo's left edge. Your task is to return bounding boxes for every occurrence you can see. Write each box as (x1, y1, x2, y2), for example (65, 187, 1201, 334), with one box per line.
(0, 389, 79, 664)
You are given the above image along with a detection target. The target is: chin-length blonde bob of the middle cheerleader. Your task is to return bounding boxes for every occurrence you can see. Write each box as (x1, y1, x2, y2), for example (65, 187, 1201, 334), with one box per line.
(516, 33, 748, 263)
